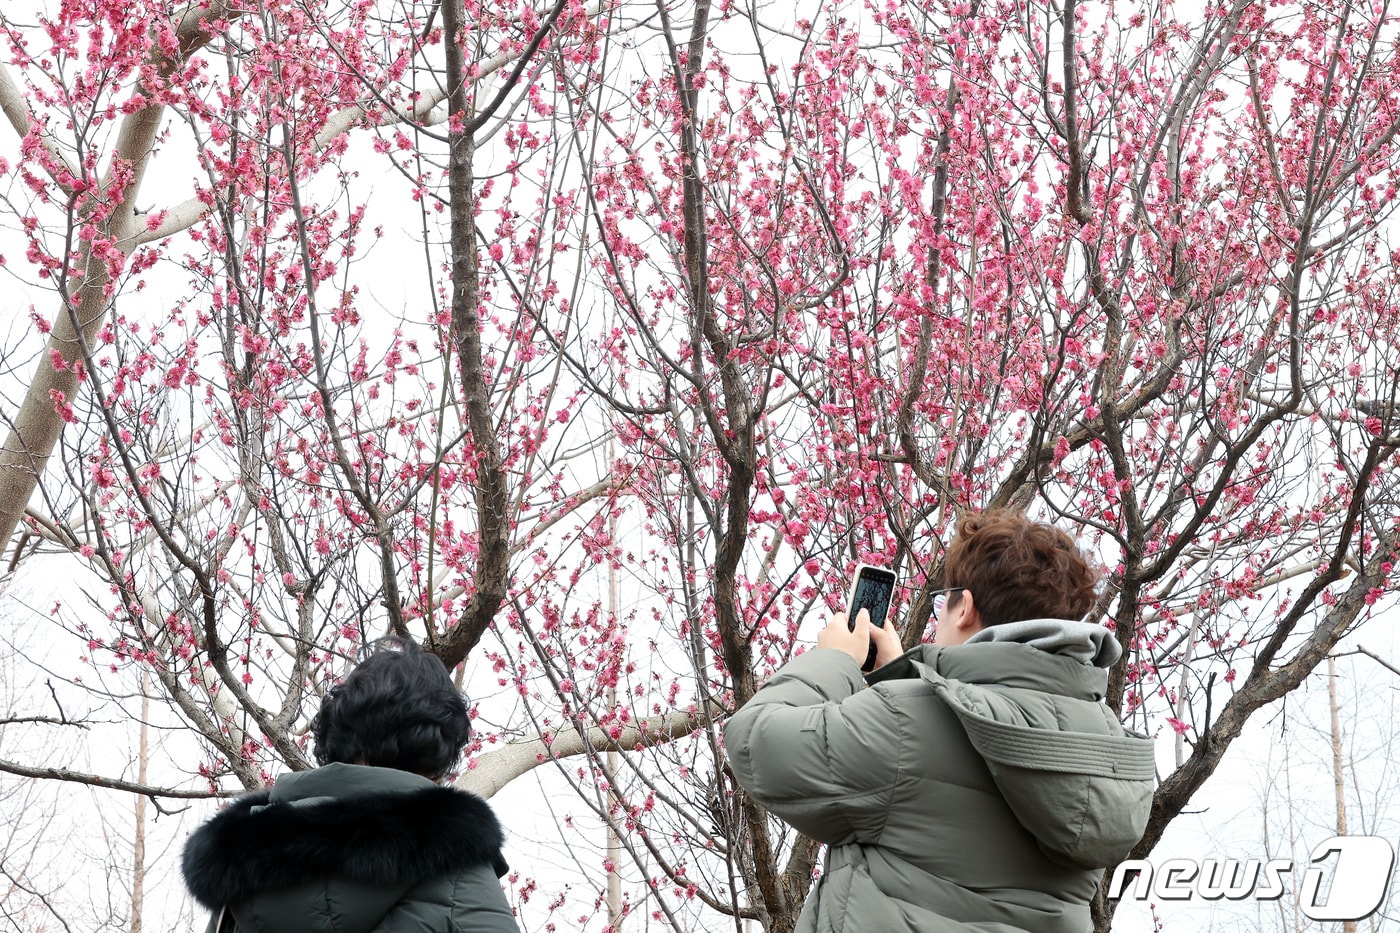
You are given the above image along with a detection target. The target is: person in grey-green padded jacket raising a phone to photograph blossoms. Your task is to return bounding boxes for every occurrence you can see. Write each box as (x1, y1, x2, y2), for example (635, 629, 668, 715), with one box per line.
(724, 511, 1156, 933)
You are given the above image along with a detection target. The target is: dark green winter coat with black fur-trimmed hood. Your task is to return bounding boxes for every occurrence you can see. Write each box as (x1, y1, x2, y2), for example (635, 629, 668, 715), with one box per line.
(182, 763, 519, 933)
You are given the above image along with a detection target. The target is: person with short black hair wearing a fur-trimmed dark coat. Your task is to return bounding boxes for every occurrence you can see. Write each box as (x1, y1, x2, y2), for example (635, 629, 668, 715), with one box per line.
(182, 639, 519, 933)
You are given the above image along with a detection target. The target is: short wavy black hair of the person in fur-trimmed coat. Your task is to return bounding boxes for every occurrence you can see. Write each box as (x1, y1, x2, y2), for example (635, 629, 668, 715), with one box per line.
(311, 639, 472, 780)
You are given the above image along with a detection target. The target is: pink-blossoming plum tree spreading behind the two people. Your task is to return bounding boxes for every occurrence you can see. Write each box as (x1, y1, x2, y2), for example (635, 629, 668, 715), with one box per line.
(0, 0, 1400, 930)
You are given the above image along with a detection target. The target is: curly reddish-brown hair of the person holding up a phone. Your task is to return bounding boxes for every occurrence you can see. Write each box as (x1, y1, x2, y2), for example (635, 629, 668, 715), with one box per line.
(944, 509, 1099, 626)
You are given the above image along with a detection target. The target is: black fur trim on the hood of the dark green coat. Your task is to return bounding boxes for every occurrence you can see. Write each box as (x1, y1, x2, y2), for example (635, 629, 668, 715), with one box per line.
(182, 787, 507, 909)
